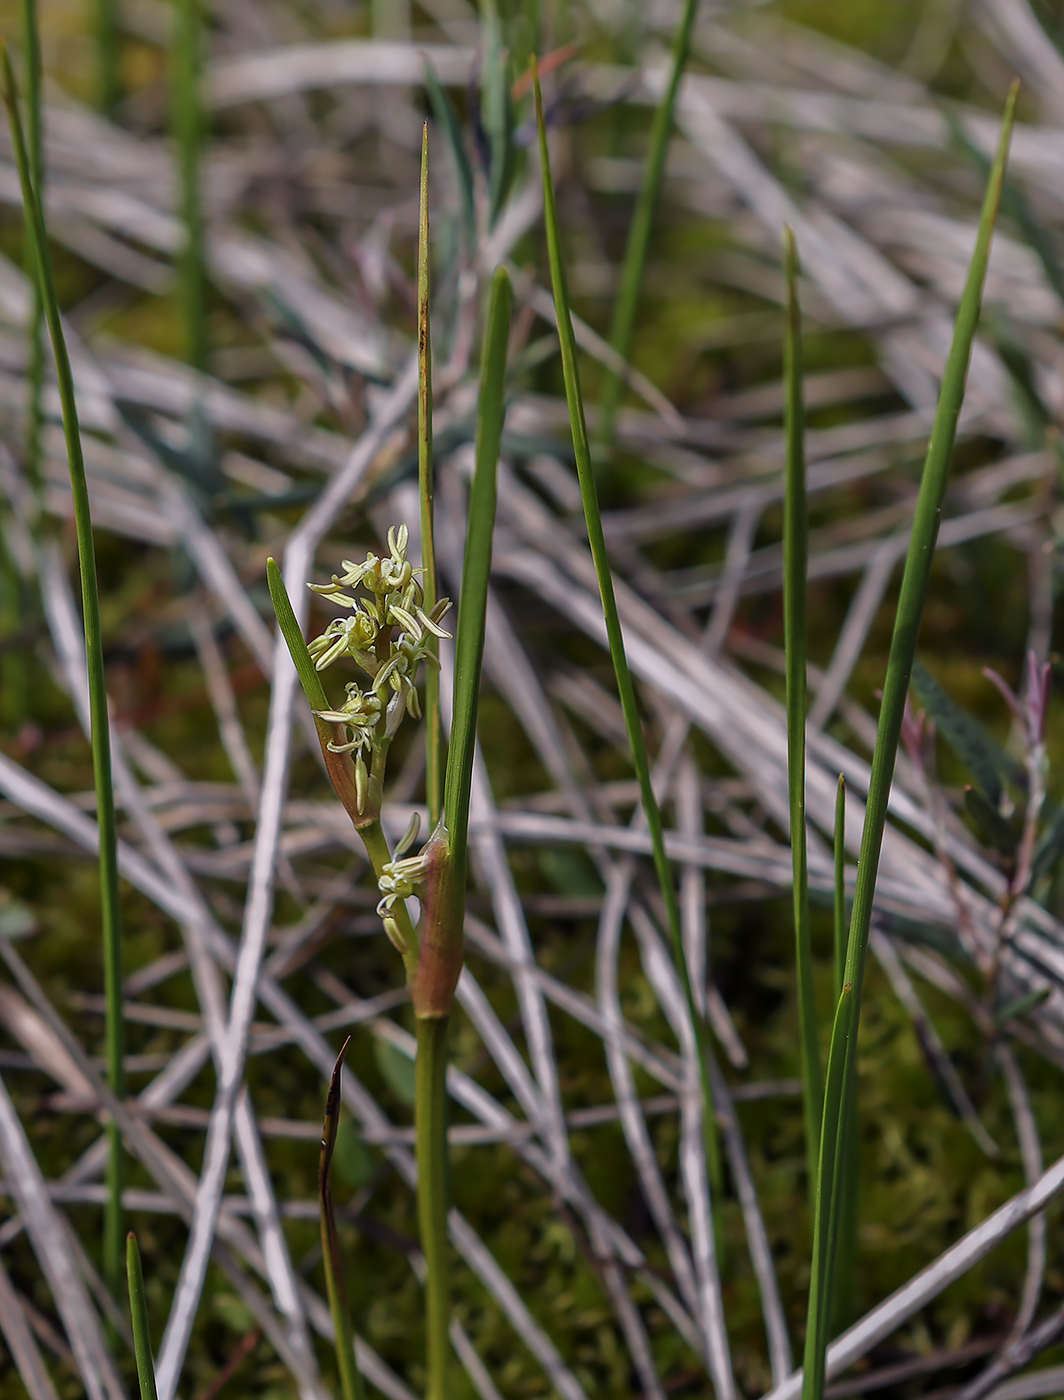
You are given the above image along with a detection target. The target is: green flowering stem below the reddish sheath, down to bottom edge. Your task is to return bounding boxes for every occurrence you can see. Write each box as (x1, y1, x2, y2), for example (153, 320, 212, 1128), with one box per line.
(414, 1016, 451, 1400)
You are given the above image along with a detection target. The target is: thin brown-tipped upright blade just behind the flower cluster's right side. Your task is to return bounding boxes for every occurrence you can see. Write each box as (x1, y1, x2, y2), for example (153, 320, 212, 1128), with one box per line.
(417, 122, 444, 830)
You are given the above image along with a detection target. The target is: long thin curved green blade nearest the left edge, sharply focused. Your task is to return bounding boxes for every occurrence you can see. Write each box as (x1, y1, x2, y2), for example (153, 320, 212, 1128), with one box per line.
(0, 45, 126, 1296)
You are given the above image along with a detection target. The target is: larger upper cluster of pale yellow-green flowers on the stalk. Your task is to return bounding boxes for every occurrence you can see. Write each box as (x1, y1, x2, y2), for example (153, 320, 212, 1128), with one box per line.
(309, 525, 451, 812)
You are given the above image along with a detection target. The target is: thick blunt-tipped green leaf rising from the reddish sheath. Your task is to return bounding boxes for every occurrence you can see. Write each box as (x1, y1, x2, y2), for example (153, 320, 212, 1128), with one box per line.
(444, 267, 512, 868)
